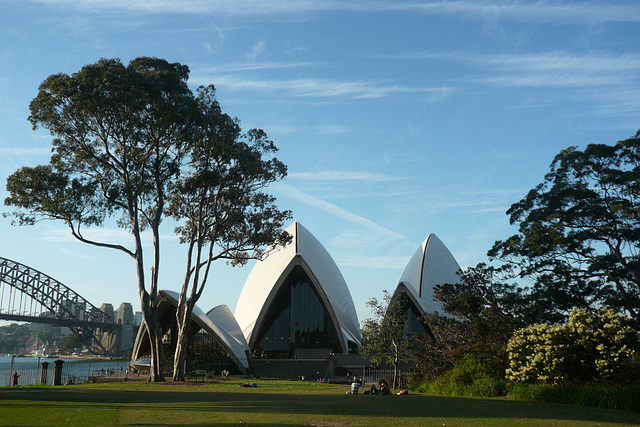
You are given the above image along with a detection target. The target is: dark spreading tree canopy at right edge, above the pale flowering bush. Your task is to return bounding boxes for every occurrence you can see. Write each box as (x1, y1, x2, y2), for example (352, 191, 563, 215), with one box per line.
(489, 131, 640, 317)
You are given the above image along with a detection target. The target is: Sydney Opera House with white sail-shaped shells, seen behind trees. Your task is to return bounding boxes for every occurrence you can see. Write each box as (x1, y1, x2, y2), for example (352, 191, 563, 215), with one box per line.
(132, 222, 459, 373)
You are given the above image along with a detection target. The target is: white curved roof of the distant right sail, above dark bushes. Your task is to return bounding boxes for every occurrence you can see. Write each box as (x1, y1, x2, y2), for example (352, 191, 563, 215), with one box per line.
(392, 234, 460, 312)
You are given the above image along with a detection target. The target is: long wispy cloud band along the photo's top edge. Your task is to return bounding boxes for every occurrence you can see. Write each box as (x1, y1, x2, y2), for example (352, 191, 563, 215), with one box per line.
(27, 0, 640, 24)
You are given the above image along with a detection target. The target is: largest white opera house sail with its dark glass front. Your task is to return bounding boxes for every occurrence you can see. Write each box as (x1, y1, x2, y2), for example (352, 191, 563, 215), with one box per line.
(235, 222, 361, 359)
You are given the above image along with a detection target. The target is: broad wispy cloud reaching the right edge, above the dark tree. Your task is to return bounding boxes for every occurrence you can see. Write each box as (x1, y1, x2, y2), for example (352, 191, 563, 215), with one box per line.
(379, 51, 640, 108)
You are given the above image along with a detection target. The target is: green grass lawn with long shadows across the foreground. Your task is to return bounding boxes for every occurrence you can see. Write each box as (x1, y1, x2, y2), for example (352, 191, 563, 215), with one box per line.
(0, 380, 640, 427)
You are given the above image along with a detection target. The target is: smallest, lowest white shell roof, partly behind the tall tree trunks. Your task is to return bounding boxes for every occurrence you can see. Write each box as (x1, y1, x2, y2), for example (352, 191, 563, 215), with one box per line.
(160, 290, 249, 371)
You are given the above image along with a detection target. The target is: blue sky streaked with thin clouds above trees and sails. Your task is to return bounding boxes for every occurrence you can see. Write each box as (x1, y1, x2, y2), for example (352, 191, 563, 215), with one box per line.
(0, 0, 640, 320)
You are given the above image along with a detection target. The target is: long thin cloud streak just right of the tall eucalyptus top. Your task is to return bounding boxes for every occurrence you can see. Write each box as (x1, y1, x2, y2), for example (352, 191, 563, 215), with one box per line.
(192, 75, 451, 99)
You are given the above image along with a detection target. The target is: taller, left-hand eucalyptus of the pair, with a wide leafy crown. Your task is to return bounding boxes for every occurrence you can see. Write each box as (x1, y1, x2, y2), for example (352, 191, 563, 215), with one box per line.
(5, 57, 196, 381)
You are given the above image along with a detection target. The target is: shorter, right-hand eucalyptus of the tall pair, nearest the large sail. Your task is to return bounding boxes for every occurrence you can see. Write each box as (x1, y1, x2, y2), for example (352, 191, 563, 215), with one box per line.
(168, 86, 290, 380)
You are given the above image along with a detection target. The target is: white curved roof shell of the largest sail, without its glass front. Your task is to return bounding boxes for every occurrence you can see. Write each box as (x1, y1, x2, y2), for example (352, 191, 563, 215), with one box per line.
(235, 222, 361, 353)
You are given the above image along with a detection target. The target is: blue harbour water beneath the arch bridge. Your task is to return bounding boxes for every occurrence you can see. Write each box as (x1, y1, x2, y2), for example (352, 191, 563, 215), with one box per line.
(0, 355, 130, 387)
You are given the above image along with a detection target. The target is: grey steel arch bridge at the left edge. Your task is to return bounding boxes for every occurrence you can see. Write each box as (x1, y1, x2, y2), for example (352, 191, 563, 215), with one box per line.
(0, 257, 120, 354)
